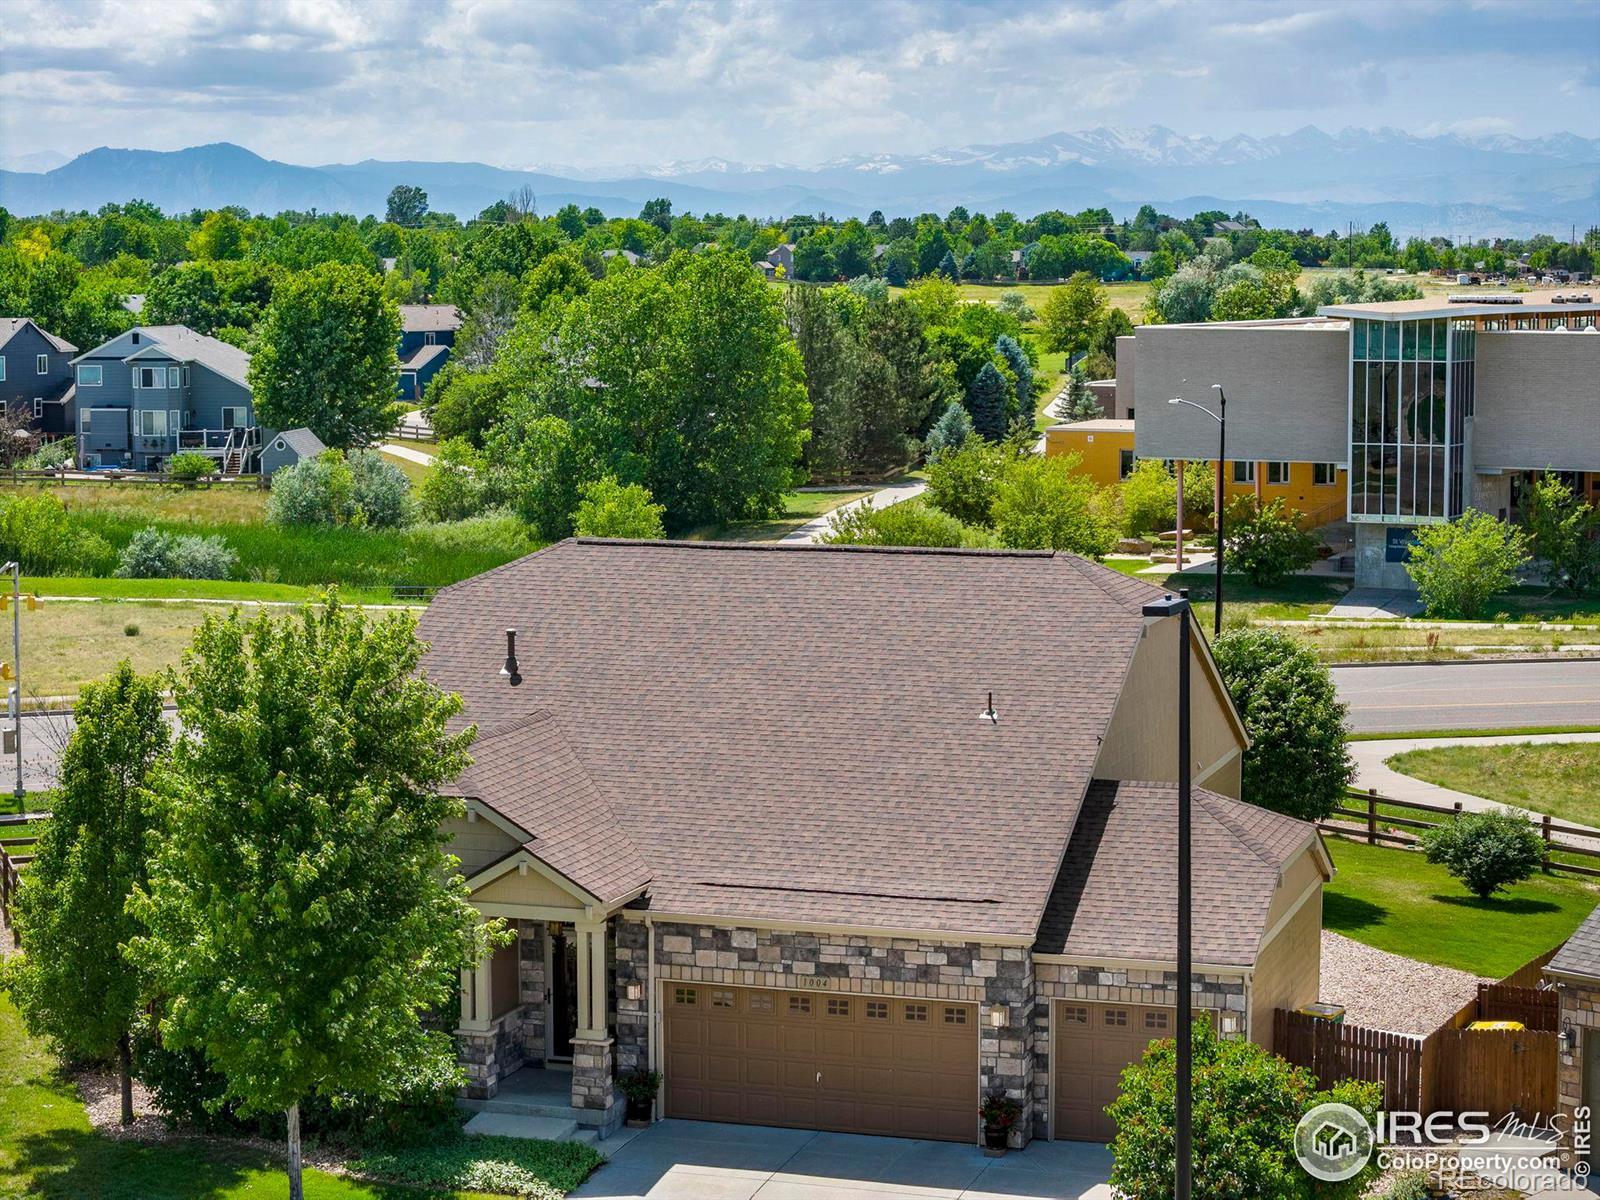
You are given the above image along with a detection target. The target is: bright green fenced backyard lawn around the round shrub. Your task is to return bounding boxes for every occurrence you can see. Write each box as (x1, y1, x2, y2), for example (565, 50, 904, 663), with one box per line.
(1322, 838, 1600, 979)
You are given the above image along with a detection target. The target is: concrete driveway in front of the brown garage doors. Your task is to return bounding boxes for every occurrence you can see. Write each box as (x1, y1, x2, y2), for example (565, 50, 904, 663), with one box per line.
(573, 1120, 1110, 1200)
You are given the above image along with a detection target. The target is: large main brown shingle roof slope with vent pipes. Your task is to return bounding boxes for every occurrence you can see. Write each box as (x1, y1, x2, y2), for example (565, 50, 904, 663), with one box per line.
(421, 539, 1154, 938)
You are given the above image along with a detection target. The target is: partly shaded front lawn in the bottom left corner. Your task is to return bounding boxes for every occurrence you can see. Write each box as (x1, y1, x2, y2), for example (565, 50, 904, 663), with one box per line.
(0, 994, 598, 1200)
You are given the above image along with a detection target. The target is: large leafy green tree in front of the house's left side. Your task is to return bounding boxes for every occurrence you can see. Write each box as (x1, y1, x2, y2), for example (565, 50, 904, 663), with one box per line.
(128, 598, 502, 1200)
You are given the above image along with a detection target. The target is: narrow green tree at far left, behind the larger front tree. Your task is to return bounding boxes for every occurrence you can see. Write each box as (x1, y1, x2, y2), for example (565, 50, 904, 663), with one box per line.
(5, 662, 170, 1125)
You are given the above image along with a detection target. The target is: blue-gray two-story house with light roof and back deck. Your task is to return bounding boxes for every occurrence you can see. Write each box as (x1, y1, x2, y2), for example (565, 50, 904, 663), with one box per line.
(72, 325, 262, 475)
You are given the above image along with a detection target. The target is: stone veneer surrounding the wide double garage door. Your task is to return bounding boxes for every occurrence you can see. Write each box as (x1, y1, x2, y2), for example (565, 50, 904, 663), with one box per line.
(616, 920, 1035, 1146)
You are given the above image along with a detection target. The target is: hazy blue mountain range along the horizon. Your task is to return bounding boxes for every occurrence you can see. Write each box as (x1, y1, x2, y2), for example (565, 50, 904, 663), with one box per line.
(0, 126, 1600, 237)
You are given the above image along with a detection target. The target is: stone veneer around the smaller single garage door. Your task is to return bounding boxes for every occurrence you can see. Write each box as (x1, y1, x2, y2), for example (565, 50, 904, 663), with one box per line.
(1034, 963, 1270, 1138)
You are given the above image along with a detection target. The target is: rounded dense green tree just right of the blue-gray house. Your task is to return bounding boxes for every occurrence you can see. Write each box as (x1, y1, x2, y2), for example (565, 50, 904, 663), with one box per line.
(250, 262, 400, 448)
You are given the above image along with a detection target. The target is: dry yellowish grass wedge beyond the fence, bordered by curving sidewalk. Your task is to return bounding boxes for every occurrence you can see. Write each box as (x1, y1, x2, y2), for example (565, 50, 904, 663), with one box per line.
(1389, 742, 1600, 826)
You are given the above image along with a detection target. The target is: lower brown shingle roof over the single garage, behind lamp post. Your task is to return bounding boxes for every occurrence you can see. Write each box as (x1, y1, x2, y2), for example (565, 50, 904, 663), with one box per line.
(1034, 779, 1315, 966)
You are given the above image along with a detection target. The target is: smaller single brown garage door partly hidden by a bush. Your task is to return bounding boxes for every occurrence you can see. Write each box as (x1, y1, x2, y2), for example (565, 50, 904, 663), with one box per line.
(1053, 1002, 1178, 1142)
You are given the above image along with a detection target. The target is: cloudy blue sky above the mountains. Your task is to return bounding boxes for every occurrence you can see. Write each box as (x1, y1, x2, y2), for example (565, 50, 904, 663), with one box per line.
(0, 0, 1600, 170)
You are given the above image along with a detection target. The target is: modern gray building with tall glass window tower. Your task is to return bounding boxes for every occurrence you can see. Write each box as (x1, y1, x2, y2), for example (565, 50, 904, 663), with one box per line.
(1117, 290, 1600, 587)
